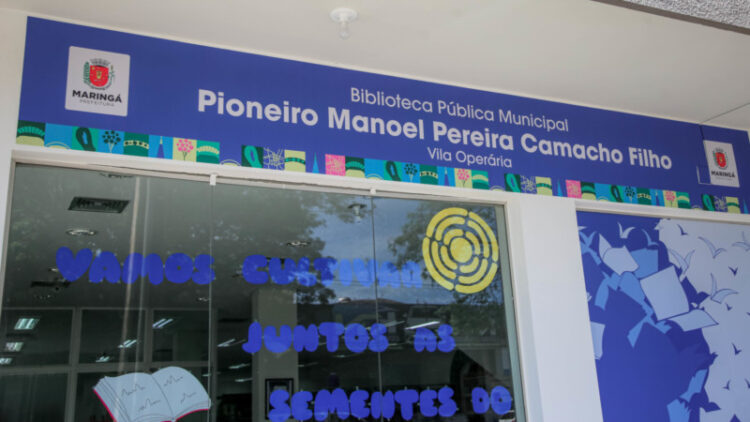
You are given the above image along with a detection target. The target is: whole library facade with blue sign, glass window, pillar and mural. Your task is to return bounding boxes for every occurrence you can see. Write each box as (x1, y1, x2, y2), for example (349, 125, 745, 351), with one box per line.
(0, 4, 750, 422)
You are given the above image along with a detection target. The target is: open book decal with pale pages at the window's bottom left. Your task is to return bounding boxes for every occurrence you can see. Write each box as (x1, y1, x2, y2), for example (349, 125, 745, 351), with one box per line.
(94, 366, 211, 422)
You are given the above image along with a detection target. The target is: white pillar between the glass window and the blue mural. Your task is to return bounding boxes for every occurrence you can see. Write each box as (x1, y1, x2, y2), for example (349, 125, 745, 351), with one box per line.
(508, 195, 602, 422)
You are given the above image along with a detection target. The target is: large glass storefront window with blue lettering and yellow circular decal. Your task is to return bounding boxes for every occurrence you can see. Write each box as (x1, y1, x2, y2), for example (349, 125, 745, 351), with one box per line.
(0, 166, 523, 422)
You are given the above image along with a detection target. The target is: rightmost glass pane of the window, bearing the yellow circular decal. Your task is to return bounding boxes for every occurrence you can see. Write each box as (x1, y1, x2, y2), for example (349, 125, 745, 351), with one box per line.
(374, 198, 520, 420)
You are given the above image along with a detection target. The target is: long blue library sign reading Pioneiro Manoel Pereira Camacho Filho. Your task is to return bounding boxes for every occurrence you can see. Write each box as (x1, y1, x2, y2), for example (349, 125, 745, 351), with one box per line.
(17, 18, 750, 213)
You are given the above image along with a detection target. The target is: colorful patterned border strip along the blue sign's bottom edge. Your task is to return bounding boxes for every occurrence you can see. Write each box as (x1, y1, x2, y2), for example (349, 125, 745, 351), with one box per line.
(16, 120, 750, 214)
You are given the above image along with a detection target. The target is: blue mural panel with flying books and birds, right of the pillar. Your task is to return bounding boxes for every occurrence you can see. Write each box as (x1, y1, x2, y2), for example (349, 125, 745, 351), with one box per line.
(578, 212, 750, 422)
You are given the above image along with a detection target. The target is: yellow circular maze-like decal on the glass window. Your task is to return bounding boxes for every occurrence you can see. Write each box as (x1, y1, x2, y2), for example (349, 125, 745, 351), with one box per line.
(422, 208, 498, 294)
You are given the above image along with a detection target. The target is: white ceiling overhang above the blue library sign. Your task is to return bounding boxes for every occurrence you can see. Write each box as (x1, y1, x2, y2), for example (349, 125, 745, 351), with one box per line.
(0, 0, 750, 129)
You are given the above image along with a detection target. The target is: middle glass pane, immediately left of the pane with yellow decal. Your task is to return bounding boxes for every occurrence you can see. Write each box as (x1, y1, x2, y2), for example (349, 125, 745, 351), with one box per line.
(211, 185, 379, 421)
